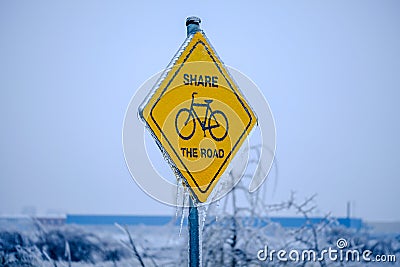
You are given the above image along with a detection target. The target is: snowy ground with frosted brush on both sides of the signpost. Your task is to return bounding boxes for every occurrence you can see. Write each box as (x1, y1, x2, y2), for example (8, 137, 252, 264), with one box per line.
(0, 216, 400, 267)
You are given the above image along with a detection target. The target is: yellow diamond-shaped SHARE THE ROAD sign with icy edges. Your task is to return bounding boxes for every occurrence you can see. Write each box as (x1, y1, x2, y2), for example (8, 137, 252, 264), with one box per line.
(139, 31, 257, 202)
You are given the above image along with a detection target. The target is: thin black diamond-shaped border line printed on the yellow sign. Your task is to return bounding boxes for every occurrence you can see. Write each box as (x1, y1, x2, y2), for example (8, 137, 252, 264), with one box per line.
(150, 37, 253, 194)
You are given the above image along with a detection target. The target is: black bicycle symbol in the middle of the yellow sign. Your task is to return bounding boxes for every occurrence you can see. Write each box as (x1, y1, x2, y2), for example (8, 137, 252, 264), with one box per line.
(175, 92, 229, 141)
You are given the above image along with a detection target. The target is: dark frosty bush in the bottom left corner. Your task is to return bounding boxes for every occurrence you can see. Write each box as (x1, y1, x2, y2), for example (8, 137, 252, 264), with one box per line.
(0, 225, 131, 267)
